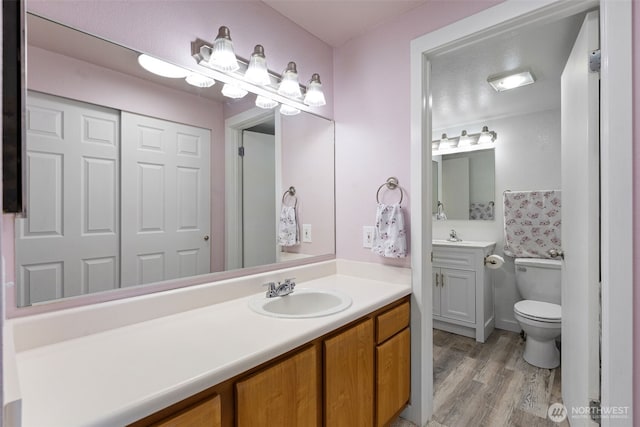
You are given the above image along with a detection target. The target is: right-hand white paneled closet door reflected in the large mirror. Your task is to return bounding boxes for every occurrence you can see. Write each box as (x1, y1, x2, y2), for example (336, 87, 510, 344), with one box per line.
(122, 112, 211, 286)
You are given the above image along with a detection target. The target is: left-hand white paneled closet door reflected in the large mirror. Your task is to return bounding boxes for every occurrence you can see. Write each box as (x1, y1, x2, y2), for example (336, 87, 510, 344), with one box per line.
(16, 92, 120, 306)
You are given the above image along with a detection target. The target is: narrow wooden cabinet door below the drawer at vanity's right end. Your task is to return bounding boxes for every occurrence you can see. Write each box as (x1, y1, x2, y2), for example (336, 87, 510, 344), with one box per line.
(376, 328, 411, 426)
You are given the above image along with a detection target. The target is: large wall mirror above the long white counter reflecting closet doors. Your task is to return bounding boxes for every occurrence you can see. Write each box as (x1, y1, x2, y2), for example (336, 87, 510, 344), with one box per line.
(15, 14, 335, 306)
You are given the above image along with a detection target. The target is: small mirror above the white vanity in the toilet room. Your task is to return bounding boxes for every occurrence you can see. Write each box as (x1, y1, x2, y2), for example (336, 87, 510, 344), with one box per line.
(432, 147, 495, 221)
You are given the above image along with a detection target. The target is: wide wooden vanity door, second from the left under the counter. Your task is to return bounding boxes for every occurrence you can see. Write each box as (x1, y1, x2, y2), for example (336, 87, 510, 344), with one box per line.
(236, 347, 320, 427)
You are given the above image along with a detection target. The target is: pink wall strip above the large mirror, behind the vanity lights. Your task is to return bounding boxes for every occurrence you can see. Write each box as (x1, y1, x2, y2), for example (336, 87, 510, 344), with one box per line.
(27, 0, 333, 117)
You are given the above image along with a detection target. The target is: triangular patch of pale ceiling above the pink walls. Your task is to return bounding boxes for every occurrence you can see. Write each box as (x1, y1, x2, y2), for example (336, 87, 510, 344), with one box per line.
(262, 0, 427, 47)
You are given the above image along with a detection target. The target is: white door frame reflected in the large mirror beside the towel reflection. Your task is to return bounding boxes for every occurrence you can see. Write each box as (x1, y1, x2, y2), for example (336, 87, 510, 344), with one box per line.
(224, 107, 282, 271)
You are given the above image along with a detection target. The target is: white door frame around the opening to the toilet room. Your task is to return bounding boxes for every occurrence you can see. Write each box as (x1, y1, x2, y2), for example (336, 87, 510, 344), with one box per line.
(405, 0, 633, 426)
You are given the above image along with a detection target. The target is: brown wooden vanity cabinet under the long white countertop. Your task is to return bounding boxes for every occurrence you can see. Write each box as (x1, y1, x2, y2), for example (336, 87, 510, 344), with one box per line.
(131, 297, 411, 427)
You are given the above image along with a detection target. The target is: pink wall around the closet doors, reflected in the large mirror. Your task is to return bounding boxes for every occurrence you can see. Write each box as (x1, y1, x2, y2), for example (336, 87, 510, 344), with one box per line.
(26, 46, 224, 271)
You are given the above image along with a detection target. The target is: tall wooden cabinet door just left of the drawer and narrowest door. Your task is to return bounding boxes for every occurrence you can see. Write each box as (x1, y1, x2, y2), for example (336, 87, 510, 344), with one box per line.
(324, 319, 374, 427)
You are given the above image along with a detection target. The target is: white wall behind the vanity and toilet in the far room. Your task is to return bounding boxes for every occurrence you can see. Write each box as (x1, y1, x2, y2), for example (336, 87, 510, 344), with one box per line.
(433, 109, 560, 332)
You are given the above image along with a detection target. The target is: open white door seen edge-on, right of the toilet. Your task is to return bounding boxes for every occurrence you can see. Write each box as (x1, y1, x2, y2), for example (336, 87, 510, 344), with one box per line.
(561, 12, 600, 426)
